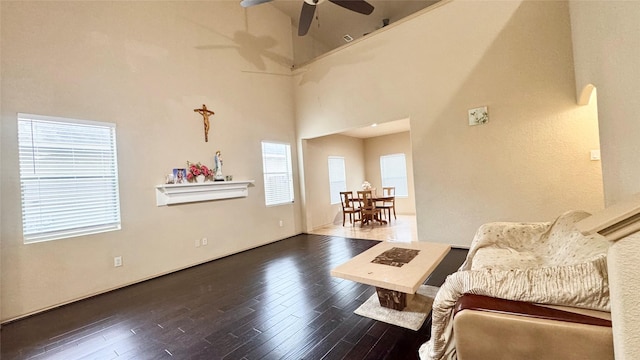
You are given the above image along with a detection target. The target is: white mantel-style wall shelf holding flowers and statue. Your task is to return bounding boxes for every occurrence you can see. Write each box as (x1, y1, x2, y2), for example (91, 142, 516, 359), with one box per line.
(156, 180, 255, 206)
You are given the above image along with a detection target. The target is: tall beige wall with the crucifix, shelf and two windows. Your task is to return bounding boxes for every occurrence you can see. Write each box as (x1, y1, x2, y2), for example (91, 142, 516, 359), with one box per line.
(0, 1, 301, 320)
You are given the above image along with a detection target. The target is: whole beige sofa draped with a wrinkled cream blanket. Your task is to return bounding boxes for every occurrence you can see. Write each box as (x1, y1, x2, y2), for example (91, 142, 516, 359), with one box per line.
(420, 211, 613, 360)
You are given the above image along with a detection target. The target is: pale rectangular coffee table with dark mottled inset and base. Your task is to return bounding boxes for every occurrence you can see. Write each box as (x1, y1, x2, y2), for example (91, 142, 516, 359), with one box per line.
(331, 241, 451, 310)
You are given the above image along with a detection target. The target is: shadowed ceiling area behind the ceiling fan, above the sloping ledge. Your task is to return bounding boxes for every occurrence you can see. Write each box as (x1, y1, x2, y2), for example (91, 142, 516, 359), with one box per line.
(269, 0, 439, 58)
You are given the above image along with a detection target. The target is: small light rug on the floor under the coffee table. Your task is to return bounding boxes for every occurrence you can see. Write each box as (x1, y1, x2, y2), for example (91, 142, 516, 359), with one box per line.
(354, 285, 439, 331)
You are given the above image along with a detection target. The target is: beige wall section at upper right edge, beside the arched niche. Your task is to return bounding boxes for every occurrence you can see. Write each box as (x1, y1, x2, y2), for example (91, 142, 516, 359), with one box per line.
(571, 1, 640, 204)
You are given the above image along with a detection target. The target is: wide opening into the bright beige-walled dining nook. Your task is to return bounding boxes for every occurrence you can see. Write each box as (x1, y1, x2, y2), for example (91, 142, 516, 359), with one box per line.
(303, 118, 416, 239)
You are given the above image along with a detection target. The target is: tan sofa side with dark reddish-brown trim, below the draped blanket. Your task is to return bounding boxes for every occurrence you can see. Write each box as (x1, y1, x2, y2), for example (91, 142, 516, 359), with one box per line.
(453, 294, 614, 360)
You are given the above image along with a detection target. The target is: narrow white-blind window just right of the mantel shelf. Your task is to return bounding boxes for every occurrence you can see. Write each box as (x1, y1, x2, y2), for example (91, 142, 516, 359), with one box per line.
(262, 141, 293, 206)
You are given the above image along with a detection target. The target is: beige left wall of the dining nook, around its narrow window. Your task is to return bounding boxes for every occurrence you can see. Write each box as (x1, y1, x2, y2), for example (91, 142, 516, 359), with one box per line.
(304, 135, 365, 230)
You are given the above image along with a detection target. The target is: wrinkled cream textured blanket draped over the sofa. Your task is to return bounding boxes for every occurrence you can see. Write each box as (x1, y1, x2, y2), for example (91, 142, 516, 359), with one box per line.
(419, 211, 610, 360)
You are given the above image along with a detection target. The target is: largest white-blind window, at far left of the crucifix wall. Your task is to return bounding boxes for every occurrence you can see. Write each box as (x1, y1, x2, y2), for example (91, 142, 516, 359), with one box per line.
(18, 114, 120, 243)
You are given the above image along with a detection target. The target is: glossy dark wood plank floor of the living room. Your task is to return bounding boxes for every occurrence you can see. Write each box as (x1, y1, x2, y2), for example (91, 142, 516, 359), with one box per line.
(0, 234, 467, 360)
